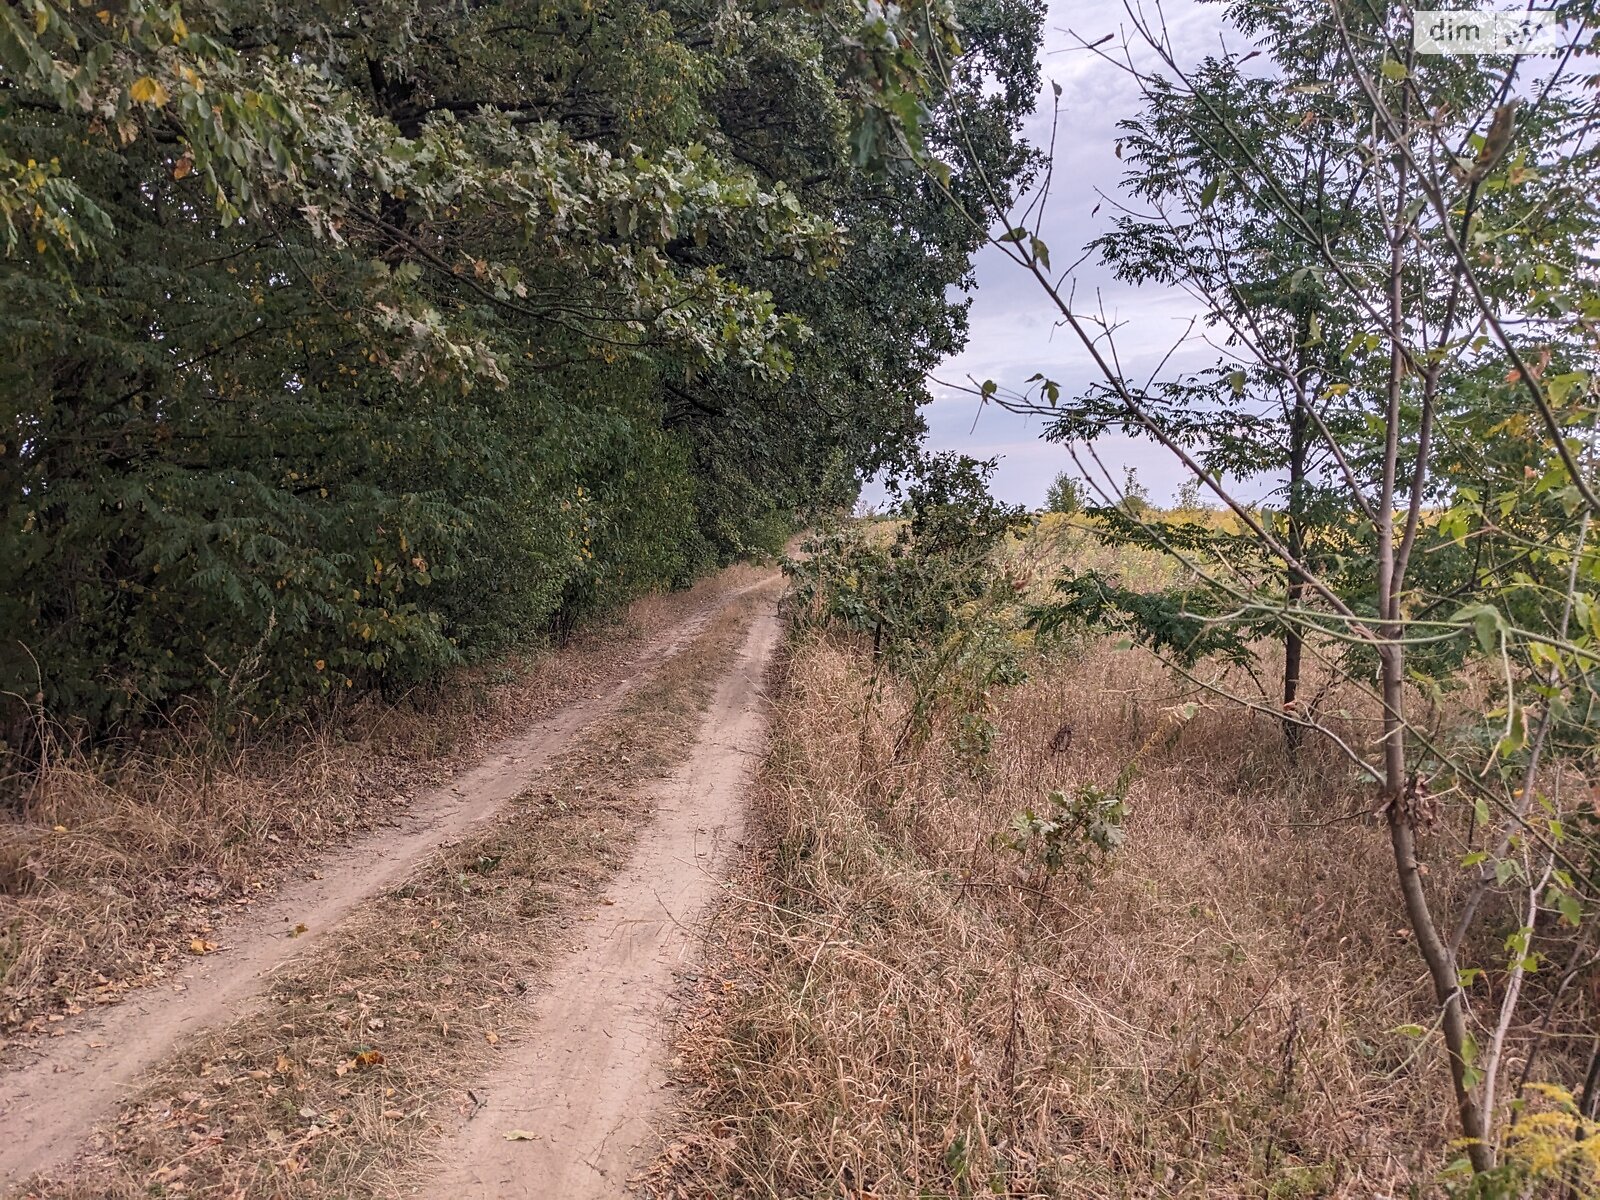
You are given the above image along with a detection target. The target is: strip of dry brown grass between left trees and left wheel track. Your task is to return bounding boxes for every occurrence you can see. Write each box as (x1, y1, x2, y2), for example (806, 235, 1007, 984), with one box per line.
(0, 568, 774, 1051)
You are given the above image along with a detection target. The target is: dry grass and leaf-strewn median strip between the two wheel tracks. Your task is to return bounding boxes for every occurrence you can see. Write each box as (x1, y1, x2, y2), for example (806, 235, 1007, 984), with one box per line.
(21, 589, 771, 1200)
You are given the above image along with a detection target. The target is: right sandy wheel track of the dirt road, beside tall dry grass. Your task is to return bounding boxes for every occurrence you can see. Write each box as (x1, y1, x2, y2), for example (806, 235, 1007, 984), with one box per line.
(422, 613, 779, 1200)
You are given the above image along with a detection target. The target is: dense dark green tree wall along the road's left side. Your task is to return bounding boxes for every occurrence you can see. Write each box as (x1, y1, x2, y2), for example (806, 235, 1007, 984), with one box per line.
(0, 0, 1042, 738)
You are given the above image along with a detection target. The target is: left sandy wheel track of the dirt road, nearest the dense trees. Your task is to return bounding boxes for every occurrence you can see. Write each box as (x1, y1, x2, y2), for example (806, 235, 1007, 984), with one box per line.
(0, 587, 750, 1194)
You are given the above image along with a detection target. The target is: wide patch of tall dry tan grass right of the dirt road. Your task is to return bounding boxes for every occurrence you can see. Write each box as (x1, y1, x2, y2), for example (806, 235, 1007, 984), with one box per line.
(653, 640, 1472, 1198)
